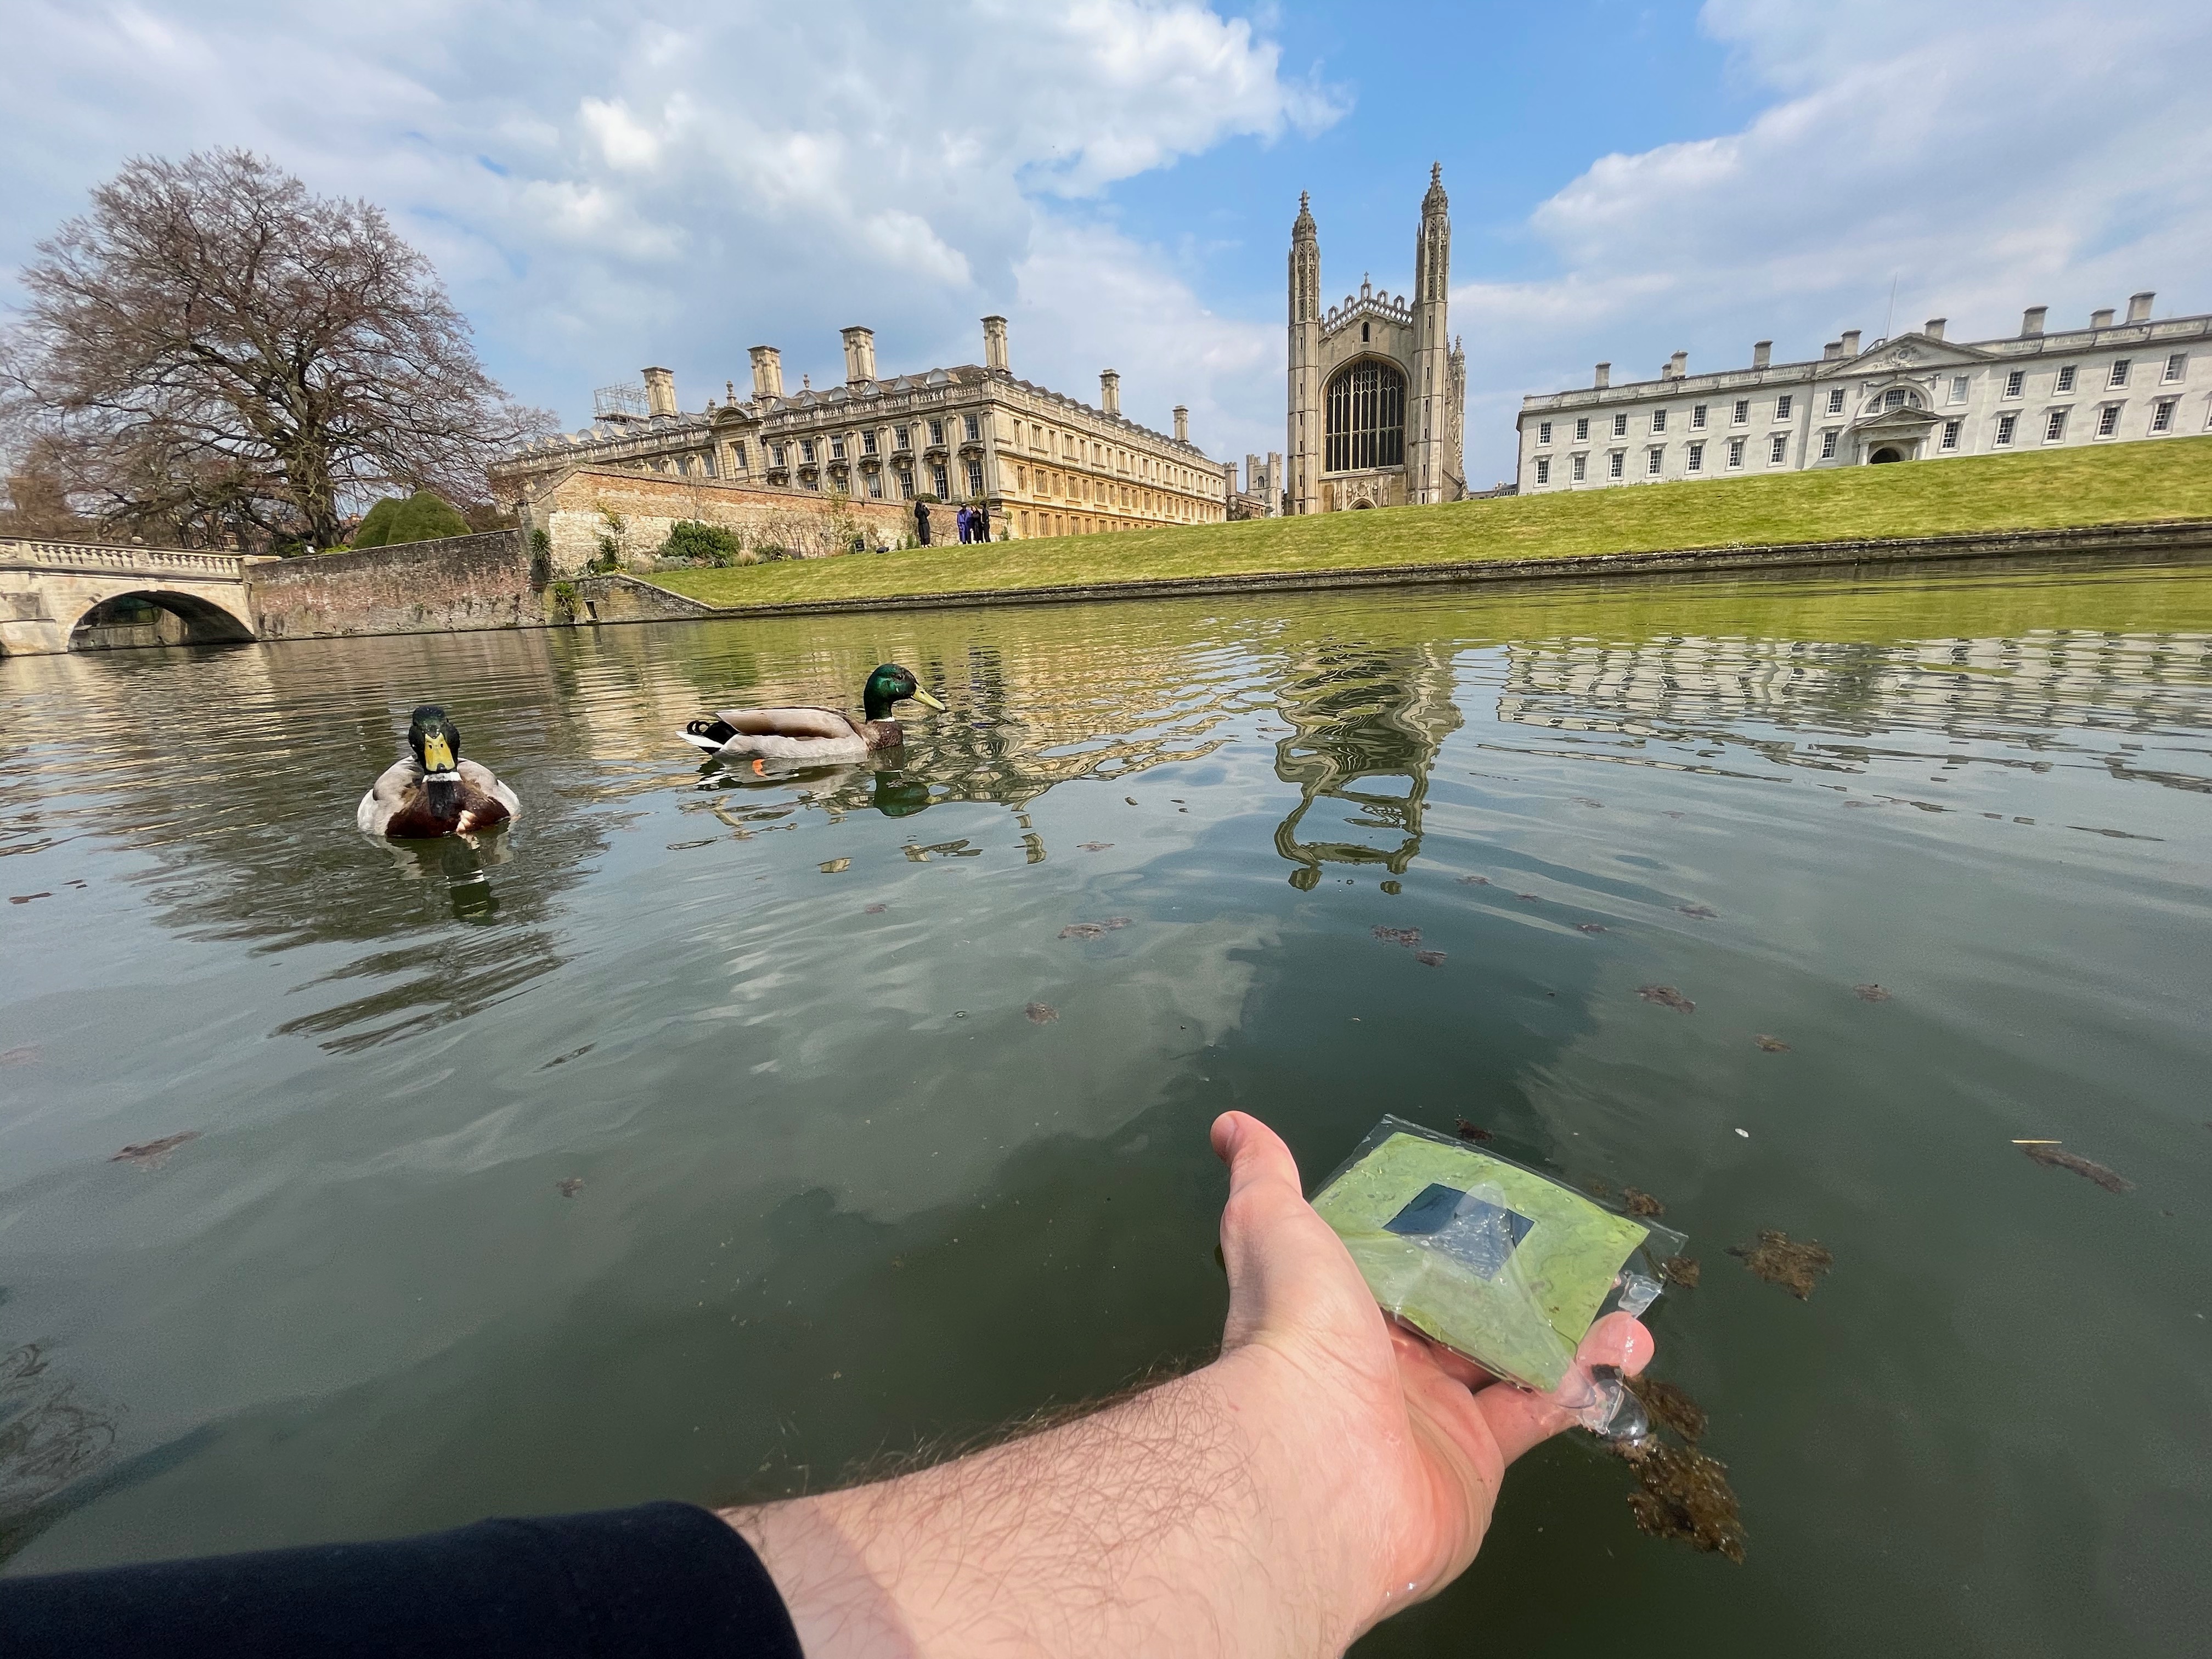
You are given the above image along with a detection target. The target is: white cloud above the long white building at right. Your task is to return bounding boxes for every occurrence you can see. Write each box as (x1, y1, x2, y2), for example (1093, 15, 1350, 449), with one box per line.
(1453, 0, 2212, 480)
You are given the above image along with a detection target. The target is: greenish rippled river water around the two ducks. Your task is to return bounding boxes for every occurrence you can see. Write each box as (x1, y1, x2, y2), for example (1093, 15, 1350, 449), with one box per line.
(0, 564, 2212, 1655)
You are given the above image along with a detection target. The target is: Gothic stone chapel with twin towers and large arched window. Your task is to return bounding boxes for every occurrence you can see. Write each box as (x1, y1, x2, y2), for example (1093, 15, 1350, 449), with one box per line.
(1285, 166, 1466, 513)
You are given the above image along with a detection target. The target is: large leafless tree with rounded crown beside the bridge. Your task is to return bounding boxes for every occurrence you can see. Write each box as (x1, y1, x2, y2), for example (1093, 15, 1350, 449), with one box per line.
(0, 150, 553, 546)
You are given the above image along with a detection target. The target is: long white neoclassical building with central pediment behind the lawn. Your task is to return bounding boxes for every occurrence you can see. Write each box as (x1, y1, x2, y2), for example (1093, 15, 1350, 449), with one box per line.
(1517, 292, 2212, 495)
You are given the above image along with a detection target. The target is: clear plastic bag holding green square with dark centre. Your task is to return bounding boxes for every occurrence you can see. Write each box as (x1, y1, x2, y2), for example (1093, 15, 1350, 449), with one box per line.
(1314, 1117, 1685, 1440)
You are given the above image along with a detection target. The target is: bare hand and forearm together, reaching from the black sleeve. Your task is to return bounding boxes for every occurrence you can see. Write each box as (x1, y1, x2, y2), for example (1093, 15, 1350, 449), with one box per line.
(723, 1113, 1652, 1659)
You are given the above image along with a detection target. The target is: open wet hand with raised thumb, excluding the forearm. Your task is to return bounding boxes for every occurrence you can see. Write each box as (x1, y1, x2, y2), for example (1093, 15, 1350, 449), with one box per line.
(1212, 1113, 1652, 1635)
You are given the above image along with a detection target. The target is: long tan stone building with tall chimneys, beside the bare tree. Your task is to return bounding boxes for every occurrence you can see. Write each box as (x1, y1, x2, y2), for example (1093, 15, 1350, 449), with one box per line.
(491, 317, 1230, 544)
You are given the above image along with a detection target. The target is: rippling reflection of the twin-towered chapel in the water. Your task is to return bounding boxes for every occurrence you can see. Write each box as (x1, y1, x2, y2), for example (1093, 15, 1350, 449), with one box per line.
(1274, 646, 1462, 891)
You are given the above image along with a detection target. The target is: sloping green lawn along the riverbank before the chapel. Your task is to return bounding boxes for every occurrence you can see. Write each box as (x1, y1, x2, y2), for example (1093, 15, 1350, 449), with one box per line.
(652, 438, 2212, 606)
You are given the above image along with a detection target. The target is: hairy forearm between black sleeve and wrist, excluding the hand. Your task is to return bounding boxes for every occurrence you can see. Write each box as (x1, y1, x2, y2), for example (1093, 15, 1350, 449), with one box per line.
(725, 1350, 1376, 1659)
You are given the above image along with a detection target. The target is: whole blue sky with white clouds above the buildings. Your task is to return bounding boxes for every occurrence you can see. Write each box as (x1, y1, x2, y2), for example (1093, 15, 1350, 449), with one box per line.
(0, 0, 2212, 484)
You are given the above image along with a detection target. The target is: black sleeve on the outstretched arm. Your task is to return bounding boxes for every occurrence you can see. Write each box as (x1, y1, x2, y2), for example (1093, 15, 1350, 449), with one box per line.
(0, 1504, 803, 1659)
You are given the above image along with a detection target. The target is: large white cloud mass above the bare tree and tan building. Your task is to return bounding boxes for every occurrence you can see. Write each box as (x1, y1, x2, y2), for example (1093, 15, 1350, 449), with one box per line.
(0, 0, 1340, 462)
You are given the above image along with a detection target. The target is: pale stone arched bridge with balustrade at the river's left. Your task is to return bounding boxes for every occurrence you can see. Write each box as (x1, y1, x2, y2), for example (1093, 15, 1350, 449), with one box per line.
(0, 538, 266, 657)
